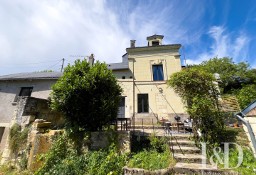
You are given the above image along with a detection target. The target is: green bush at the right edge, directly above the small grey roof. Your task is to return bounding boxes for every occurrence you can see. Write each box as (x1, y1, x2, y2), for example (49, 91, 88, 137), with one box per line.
(236, 84, 256, 109)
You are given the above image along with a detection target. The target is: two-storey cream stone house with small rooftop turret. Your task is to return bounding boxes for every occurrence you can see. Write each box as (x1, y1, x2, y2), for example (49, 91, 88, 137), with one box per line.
(108, 35, 187, 124)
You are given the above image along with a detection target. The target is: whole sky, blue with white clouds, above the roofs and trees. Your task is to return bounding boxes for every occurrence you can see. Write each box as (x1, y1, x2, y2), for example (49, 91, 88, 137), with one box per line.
(0, 0, 256, 75)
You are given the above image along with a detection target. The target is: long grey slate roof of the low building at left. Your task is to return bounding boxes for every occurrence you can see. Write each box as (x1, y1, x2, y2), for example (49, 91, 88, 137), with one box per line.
(0, 72, 62, 81)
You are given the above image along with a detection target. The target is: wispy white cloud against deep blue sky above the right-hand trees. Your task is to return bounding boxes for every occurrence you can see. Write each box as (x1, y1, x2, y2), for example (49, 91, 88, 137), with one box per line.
(187, 26, 250, 64)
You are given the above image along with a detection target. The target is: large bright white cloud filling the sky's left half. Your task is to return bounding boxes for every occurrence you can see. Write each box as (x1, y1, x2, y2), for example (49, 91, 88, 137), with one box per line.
(0, 0, 132, 74)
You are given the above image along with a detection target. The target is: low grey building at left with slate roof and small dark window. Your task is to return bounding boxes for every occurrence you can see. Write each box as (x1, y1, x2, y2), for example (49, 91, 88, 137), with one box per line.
(0, 72, 62, 152)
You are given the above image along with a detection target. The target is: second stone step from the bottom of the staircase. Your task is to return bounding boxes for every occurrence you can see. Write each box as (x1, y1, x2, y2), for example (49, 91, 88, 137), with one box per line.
(174, 153, 207, 163)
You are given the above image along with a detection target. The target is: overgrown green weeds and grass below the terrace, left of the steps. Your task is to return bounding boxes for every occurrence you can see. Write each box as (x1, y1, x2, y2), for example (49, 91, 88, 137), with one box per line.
(35, 134, 174, 175)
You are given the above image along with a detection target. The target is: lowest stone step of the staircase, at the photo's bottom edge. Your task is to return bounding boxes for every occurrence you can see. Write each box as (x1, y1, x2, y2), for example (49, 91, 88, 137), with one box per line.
(174, 162, 223, 174)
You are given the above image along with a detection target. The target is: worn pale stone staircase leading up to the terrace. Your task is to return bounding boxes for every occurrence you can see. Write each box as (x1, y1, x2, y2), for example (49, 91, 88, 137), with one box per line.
(170, 134, 236, 175)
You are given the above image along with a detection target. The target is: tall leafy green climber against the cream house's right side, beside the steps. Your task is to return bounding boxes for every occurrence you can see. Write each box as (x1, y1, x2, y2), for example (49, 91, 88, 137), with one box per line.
(168, 67, 224, 144)
